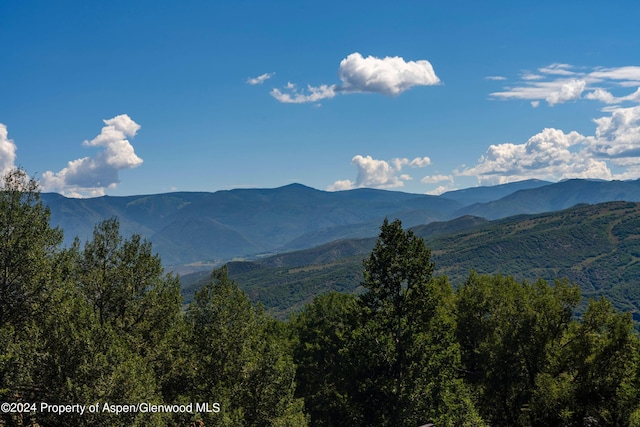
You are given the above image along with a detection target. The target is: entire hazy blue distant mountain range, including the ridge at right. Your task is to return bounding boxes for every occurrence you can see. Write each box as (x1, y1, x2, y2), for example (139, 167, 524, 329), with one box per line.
(42, 180, 640, 272)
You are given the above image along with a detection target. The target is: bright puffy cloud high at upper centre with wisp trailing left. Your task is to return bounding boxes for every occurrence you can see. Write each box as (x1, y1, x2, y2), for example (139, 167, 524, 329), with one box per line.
(270, 52, 440, 104)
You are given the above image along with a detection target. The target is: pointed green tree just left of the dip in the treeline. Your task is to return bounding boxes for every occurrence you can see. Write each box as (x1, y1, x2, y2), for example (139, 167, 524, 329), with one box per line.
(186, 267, 306, 427)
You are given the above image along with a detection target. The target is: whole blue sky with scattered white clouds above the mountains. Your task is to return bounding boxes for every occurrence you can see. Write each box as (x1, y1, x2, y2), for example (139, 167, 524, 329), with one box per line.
(0, 0, 640, 197)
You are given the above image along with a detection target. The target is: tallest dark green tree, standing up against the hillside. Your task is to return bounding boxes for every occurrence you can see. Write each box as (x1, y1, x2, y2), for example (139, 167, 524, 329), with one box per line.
(351, 220, 482, 426)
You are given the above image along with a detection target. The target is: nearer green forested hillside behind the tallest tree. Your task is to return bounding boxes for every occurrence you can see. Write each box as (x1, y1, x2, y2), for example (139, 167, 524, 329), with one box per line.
(184, 202, 640, 320)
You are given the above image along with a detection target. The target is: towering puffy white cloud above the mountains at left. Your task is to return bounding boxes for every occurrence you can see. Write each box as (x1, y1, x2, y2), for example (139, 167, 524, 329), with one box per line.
(42, 114, 142, 197)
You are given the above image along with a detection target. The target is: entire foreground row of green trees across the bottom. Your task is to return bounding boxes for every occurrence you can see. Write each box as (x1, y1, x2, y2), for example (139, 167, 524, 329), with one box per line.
(0, 170, 640, 427)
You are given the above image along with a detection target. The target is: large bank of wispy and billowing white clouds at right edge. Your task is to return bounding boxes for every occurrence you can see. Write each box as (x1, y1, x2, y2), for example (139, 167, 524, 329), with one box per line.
(462, 64, 640, 184)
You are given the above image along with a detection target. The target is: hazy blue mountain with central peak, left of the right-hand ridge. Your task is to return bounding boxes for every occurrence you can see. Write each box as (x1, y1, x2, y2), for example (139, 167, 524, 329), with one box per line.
(42, 184, 462, 266)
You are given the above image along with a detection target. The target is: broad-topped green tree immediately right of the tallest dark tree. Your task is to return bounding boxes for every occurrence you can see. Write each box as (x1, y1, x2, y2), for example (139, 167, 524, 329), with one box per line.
(456, 272, 580, 425)
